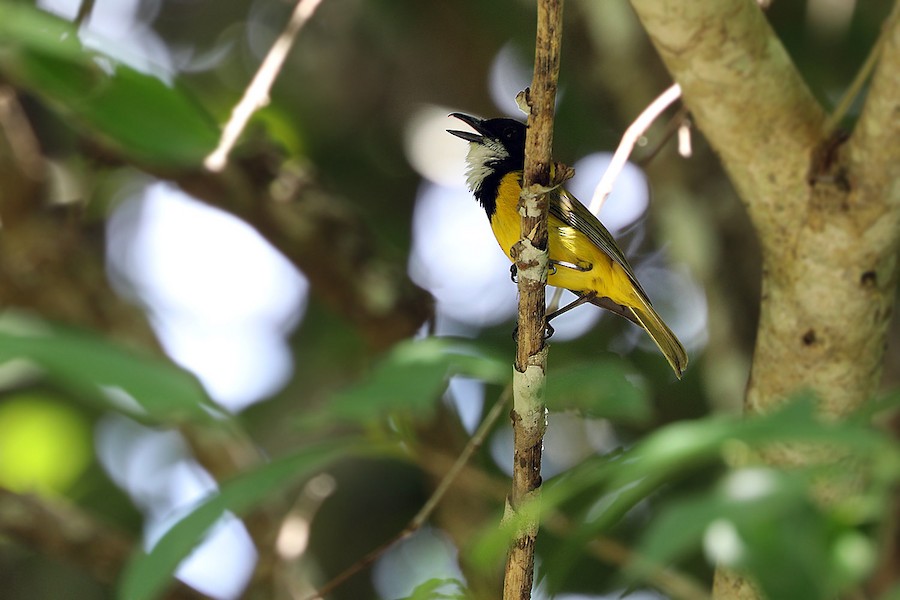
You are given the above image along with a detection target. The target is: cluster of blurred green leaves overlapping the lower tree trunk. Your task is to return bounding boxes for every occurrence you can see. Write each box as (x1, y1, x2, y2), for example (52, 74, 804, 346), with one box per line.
(543, 395, 900, 598)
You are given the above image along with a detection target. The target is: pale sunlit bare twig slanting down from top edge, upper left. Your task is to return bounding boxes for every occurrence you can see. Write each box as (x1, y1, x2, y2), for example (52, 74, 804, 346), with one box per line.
(203, 0, 321, 171)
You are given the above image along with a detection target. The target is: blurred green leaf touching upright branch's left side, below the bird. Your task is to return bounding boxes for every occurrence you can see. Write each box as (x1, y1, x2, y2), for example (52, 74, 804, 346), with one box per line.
(316, 338, 512, 423)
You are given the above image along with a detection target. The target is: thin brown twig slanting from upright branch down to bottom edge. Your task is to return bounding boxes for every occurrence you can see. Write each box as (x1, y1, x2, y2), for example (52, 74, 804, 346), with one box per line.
(304, 386, 512, 600)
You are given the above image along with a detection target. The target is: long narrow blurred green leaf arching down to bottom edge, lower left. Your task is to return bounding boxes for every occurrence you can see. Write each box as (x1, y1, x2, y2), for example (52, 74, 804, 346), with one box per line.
(117, 440, 359, 600)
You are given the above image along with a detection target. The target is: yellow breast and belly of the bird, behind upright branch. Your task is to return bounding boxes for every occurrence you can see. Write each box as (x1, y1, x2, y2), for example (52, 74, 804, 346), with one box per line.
(491, 173, 643, 306)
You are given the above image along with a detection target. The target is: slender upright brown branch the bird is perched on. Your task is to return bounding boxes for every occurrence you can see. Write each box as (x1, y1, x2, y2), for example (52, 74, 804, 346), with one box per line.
(503, 0, 563, 600)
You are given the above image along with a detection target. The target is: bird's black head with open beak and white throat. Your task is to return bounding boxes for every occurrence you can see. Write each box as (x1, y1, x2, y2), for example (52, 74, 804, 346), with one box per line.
(447, 113, 525, 215)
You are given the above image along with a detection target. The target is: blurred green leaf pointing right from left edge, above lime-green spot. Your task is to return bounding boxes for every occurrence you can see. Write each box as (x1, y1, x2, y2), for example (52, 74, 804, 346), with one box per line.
(0, 313, 224, 422)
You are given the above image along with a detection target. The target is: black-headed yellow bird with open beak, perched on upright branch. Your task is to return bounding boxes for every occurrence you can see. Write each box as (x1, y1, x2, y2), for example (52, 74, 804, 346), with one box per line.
(447, 113, 688, 379)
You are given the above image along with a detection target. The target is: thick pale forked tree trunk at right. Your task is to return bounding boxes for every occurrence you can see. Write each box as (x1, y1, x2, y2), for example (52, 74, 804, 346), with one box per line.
(632, 0, 900, 599)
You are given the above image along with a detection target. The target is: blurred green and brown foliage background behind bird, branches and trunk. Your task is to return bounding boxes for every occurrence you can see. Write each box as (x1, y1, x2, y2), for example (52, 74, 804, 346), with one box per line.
(0, 0, 900, 600)
